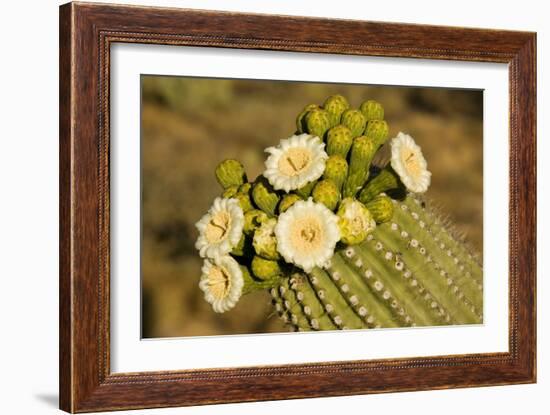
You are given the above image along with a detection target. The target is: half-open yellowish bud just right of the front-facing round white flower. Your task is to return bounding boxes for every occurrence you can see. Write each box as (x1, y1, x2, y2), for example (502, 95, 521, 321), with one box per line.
(336, 197, 376, 245)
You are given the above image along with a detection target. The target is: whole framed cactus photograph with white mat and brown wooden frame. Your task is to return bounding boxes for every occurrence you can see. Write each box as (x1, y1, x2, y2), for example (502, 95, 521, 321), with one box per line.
(60, 3, 536, 413)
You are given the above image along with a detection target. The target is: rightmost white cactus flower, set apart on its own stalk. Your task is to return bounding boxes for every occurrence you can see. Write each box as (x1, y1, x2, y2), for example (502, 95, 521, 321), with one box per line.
(391, 132, 432, 193)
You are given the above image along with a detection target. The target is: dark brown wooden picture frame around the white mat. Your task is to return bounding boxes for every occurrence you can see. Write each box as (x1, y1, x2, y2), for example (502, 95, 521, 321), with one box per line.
(60, 3, 536, 412)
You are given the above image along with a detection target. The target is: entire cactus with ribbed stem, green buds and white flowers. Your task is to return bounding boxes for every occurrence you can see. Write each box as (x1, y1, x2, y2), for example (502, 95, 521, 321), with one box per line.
(196, 95, 483, 330)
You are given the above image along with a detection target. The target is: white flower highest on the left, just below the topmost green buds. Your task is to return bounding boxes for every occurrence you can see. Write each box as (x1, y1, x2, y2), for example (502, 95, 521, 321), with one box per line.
(264, 134, 328, 193)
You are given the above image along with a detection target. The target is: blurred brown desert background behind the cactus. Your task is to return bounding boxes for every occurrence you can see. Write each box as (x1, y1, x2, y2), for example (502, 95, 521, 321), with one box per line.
(141, 75, 483, 338)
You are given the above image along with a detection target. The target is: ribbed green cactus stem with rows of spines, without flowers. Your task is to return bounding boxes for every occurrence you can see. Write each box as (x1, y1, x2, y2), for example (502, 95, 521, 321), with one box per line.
(270, 195, 483, 331)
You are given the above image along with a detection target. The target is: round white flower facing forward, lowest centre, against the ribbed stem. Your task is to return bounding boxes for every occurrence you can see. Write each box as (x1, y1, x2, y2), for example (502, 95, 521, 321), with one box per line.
(275, 198, 340, 272)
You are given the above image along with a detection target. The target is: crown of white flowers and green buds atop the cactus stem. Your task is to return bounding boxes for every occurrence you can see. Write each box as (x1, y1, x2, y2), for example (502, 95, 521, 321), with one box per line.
(196, 95, 430, 312)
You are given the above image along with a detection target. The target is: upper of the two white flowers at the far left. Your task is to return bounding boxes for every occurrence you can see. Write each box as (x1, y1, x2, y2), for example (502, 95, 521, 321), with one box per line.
(195, 197, 244, 258)
